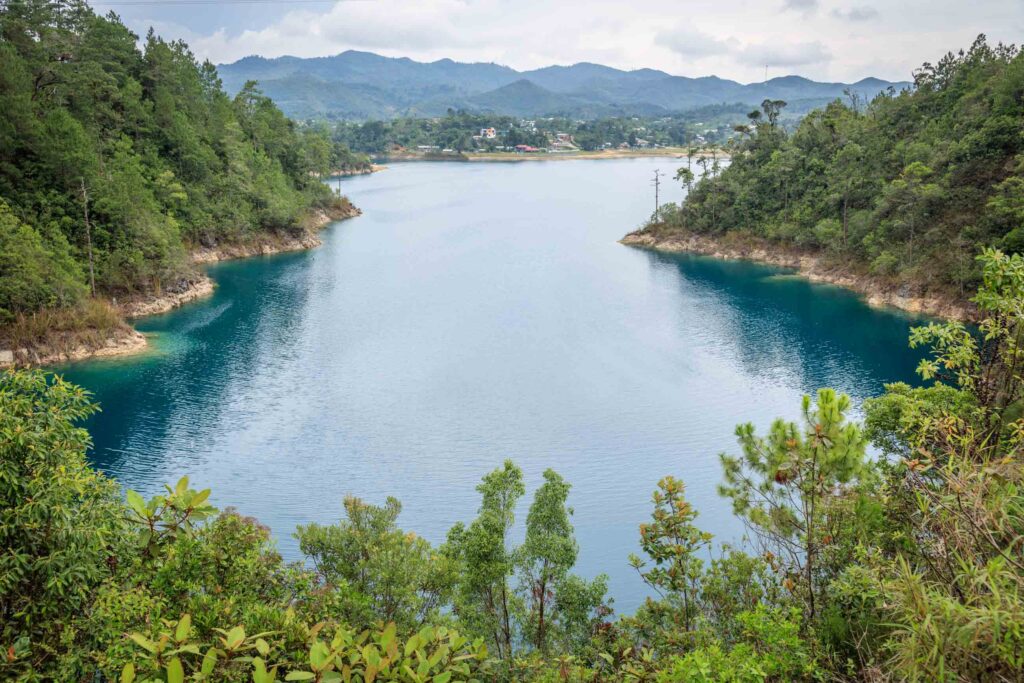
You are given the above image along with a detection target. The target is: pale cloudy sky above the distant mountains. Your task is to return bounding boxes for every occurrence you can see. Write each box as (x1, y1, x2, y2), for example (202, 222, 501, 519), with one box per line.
(94, 0, 1024, 82)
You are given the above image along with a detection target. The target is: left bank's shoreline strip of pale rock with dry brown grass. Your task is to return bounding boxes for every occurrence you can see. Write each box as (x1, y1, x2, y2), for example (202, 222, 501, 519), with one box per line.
(0, 199, 361, 370)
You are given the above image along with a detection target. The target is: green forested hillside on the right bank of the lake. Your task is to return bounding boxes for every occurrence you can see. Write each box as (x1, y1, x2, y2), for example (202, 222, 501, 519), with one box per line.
(634, 37, 1024, 296)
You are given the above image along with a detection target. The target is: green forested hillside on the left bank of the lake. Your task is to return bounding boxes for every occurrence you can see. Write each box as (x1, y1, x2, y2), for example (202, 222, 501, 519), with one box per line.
(0, 0, 364, 337)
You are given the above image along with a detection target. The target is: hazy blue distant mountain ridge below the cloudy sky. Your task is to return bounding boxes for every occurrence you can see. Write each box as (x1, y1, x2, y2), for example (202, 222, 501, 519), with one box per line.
(218, 50, 910, 120)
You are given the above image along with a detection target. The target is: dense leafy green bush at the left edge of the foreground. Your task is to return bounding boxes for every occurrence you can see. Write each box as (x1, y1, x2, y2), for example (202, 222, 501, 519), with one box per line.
(0, 372, 123, 674)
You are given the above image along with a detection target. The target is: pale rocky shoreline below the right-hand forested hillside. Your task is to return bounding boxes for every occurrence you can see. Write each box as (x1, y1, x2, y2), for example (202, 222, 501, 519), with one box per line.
(620, 230, 978, 322)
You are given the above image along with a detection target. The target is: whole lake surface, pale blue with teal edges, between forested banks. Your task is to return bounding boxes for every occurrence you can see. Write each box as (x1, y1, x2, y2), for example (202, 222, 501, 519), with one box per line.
(67, 159, 929, 611)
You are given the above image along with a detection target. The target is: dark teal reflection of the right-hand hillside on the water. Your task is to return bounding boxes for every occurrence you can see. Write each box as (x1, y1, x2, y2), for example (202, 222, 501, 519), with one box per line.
(643, 251, 925, 397)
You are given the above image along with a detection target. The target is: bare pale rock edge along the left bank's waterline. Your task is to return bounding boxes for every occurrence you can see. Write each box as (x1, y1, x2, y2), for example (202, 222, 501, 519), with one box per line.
(0, 203, 362, 368)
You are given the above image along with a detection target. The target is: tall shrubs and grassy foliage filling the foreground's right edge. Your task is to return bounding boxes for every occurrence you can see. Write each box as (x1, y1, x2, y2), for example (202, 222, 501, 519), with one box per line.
(851, 252, 1024, 681)
